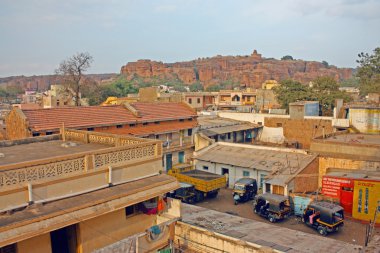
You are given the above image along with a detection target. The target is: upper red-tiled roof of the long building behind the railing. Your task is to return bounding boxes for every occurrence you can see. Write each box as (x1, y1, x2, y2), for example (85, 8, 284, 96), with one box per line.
(22, 102, 196, 131)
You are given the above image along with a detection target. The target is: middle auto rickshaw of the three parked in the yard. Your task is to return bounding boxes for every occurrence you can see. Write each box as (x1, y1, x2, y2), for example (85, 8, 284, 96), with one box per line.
(253, 193, 291, 222)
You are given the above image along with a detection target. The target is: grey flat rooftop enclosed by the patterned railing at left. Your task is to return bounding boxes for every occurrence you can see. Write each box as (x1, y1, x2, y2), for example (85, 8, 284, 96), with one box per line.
(0, 140, 110, 166)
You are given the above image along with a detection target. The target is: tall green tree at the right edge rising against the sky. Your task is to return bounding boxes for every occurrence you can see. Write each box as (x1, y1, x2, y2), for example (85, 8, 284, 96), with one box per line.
(356, 47, 380, 95)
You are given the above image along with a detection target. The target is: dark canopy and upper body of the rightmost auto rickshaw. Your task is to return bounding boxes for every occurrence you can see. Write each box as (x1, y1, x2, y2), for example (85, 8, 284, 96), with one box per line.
(307, 201, 344, 225)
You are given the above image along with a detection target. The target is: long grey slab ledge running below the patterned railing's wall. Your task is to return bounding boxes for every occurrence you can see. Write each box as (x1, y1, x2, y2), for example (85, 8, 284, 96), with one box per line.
(0, 175, 176, 231)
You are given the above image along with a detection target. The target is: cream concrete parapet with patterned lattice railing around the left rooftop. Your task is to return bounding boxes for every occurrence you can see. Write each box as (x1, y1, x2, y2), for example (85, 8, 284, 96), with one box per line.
(0, 130, 162, 212)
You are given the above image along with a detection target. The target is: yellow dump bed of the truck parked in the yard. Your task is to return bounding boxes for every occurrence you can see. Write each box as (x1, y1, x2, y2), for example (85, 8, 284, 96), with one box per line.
(168, 164, 226, 202)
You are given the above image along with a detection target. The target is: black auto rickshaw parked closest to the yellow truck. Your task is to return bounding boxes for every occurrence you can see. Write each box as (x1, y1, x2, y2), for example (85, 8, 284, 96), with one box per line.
(232, 178, 257, 205)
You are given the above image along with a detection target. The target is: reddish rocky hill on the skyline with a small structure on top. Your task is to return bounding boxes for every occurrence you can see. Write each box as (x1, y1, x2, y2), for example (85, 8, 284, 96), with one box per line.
(121, 50, 352, 88)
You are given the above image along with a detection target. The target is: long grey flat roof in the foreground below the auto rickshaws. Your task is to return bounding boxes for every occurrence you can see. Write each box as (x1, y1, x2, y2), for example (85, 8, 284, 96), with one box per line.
(181, 203, 361, 253)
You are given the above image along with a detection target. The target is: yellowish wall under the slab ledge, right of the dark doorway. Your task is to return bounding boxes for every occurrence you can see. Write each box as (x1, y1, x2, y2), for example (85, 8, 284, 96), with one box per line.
(79, 209, 156, 253)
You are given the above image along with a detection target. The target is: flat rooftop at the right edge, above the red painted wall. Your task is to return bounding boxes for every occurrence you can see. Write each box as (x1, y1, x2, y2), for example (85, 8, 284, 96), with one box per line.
(324, 133, 380, 146)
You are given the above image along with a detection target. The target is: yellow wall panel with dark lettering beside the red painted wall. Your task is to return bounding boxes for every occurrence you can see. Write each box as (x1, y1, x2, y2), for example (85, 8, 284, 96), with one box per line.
(352, 180, 380, 223)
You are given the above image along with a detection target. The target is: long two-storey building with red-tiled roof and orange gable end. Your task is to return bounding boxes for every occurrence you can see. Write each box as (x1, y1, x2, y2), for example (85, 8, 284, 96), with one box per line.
(6, 102, 197, 169)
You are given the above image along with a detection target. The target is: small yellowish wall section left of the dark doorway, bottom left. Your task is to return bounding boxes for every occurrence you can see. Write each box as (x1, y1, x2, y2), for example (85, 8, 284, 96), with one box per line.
(17, 233, 51, 253)
